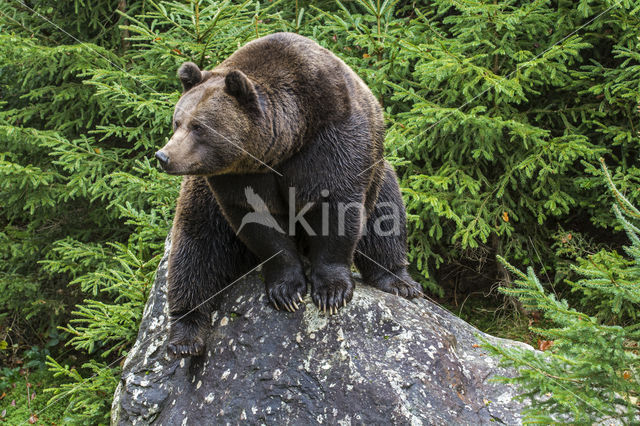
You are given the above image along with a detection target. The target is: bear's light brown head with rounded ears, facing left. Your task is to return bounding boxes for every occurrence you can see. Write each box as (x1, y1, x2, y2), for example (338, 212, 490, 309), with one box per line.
(156, 62, 264, 176)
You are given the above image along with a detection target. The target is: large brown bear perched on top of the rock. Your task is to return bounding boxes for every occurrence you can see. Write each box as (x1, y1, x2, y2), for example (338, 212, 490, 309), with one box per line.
(156, 33, 421, 356)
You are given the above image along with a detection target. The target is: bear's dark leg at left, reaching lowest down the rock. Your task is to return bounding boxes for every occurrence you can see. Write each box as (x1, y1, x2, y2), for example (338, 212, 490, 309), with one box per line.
(167, 176, 257, 357)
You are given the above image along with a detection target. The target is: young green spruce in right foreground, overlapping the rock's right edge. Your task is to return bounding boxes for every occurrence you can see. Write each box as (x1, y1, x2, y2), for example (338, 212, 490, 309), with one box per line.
(486, 163, 640, 424)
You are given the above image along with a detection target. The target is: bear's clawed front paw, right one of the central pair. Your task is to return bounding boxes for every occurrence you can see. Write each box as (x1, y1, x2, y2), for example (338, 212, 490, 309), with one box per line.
(310, 265, 355, 314)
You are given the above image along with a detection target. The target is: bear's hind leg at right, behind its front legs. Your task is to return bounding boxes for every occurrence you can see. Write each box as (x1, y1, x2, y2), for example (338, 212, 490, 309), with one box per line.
(354, 162, 422, 299)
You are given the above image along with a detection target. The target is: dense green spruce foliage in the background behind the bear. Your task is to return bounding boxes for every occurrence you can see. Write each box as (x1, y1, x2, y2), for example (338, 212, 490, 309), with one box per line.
(0, 0, 640, 423)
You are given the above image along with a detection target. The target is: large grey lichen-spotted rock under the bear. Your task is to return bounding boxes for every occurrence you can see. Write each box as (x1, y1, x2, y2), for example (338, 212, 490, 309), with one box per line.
(112, 238, 522, 425)
